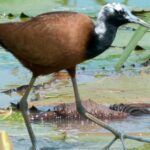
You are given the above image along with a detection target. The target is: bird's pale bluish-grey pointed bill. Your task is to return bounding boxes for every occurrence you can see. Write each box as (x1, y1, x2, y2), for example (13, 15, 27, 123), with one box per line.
(128, 14, 150, 28)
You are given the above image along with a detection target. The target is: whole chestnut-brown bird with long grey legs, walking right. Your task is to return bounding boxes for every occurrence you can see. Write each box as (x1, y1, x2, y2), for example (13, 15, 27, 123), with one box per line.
(0, 3, 150, 150)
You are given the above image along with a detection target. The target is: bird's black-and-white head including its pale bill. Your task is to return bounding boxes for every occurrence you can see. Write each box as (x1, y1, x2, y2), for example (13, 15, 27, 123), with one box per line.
(98, 3, 150, 28)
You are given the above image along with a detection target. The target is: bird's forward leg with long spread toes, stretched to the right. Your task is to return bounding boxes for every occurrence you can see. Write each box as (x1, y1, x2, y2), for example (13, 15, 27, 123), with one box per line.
(69, 69, 150, 150)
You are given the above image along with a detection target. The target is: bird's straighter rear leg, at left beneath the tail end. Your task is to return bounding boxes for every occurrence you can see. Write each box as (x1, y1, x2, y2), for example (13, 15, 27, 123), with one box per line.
(20, 77, 36, 150)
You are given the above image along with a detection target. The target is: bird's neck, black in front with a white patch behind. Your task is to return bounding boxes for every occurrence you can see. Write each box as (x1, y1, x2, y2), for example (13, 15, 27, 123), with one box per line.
(88, 19, 117, 58)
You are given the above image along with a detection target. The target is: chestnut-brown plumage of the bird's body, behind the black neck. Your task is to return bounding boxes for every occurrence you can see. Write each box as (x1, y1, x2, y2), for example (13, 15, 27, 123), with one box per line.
(0, 12, 94, 76)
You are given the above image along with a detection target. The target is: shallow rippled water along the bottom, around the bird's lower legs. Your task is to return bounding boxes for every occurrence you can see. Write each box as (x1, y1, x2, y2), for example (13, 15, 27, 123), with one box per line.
(0, 116, 150, 150)
